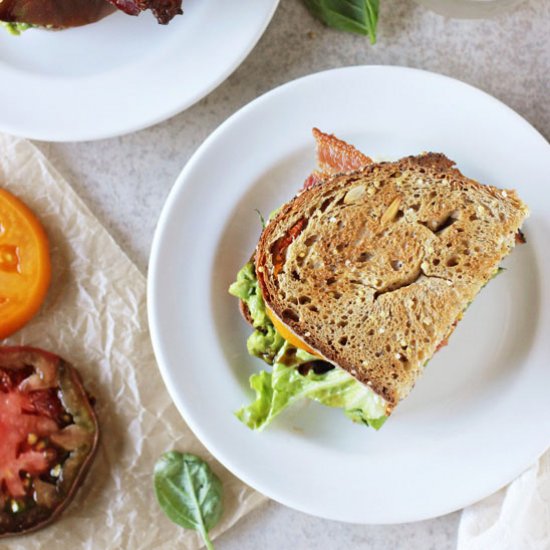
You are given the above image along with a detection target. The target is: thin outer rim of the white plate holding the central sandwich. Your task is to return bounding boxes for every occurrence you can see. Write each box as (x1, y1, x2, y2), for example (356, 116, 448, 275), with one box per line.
(147, 65, 550, 525)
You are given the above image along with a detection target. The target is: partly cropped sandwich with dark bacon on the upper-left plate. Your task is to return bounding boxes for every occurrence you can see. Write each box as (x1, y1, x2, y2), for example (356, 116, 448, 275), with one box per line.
(0, 0, 182, 34)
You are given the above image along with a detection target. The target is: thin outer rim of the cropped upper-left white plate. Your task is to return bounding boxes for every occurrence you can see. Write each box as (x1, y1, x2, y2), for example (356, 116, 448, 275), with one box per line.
(0, 0, 280, 143)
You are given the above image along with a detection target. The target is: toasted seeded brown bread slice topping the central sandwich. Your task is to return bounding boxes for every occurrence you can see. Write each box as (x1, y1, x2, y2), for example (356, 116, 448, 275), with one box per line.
(255, 153, 528, 412)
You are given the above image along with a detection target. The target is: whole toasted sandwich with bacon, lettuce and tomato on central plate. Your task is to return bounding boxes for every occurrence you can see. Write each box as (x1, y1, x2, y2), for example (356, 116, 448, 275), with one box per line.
(229, 129, 528, 430)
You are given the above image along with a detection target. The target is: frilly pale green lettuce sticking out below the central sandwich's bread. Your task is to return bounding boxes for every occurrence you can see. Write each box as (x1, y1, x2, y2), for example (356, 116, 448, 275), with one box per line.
(235, 342, 386, 430)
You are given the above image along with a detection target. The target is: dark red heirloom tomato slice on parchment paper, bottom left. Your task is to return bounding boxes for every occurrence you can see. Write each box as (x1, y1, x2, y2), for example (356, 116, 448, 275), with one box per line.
(0, 347, 99, 538)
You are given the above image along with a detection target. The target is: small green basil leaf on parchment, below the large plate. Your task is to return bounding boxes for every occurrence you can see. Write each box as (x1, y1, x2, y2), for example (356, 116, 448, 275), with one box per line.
(154, 451, 223, 550)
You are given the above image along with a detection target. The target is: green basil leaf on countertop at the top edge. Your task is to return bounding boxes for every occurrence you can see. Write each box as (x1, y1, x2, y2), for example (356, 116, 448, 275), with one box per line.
(304, 0, 379, 44)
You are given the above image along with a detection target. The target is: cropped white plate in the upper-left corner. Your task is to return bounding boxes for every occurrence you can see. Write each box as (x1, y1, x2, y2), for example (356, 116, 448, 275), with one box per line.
(0, 0, 278, 141)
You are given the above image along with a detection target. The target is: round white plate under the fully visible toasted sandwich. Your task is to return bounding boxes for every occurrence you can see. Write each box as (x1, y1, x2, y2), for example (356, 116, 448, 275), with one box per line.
(148, 67, 550, 523)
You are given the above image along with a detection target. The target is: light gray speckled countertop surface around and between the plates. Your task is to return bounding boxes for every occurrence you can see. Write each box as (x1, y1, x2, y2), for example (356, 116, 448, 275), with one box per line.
(37, 0, 550, 550)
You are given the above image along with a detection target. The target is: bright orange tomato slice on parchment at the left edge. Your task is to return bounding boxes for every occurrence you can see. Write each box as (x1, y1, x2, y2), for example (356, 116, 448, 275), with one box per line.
(0, 188, 51, 338)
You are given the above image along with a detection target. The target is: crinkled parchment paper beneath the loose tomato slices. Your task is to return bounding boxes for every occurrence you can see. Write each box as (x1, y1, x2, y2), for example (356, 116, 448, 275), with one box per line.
(0, 134, 265, 550)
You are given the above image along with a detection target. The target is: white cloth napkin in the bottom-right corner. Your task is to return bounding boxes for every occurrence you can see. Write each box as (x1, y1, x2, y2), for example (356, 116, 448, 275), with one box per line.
(457, 450, 550, 550)
